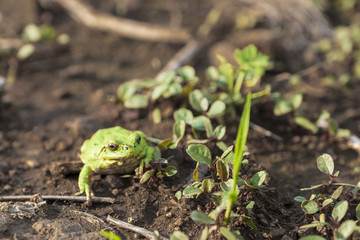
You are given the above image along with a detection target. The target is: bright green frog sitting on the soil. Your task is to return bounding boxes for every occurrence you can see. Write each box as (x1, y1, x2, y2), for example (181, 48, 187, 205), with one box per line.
(76, 126, 154, 205)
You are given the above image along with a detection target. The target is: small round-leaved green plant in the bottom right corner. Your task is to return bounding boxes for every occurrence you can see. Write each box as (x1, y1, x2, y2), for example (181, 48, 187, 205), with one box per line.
(294, 154, 360, 240)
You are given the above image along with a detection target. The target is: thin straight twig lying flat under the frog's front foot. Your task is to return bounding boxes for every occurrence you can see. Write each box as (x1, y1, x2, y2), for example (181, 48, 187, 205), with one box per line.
(0, 195, 115, 203)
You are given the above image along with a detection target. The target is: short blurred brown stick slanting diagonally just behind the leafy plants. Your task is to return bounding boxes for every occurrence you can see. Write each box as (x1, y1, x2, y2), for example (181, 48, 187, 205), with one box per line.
(158, 40, 200, 76)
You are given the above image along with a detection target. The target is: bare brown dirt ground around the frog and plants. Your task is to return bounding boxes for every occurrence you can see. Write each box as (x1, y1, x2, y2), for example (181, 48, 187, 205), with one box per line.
(0, 0, 360, 239)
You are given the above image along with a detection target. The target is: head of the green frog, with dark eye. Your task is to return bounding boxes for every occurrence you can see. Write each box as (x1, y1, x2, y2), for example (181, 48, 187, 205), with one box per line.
(100, 134, 144, 160)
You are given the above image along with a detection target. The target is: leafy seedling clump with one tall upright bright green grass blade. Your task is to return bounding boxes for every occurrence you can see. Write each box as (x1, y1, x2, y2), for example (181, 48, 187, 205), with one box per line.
(176, 94, 266, 239)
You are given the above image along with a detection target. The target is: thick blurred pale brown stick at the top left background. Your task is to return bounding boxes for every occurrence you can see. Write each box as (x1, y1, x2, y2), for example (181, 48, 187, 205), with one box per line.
(55, 0, 190, 42)
